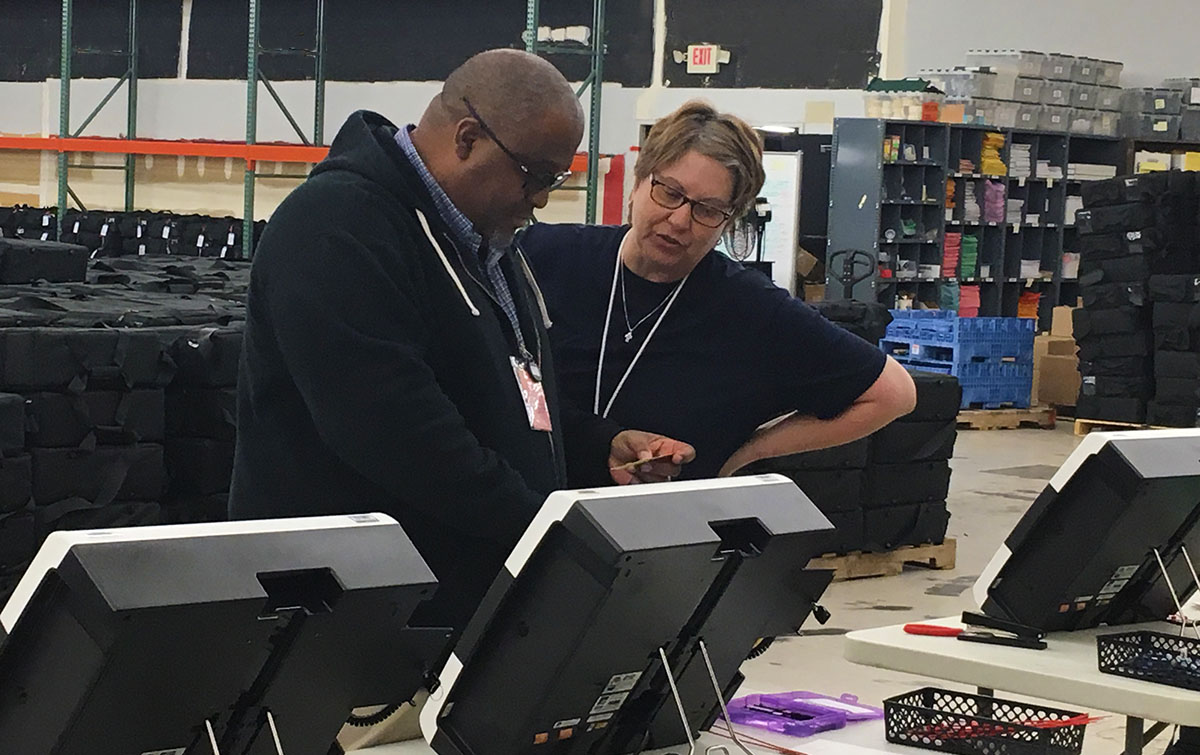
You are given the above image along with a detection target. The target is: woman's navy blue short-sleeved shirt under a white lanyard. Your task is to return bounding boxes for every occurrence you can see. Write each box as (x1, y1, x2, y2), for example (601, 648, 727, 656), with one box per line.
(518, 224, 884, 479)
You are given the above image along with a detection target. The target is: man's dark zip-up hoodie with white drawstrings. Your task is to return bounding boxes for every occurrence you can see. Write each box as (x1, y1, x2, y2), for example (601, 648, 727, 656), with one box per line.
(229, 112, 618, 629)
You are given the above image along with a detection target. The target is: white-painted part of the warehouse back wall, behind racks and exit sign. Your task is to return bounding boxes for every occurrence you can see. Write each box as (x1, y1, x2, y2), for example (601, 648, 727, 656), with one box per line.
(11, 0, 1200, 220)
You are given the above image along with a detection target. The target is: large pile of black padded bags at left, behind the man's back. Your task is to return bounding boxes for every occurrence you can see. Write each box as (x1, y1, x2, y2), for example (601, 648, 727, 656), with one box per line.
(0, 244, 250, 599)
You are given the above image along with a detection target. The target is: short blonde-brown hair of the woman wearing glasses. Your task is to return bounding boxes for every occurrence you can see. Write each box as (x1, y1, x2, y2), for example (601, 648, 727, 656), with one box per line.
(634, 100, 766, 216)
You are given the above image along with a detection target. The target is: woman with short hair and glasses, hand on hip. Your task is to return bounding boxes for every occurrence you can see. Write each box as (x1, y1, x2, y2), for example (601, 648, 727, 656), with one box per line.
(518, 102, 916, 484)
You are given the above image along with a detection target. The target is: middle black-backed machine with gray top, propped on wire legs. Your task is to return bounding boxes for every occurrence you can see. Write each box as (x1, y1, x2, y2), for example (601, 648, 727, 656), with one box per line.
(433, 475, 830, 755)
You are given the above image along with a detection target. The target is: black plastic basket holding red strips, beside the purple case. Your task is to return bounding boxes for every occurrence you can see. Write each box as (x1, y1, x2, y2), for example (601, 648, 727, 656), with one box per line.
(883, 687, 1087, 755)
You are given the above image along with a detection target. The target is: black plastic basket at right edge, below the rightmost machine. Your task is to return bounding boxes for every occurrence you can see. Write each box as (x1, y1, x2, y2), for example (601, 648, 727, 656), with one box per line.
(1096, 630, 1200, 690)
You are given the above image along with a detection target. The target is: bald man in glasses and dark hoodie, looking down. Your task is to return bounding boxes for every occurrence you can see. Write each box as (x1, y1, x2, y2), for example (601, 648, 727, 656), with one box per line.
(229, 50, 694, 631)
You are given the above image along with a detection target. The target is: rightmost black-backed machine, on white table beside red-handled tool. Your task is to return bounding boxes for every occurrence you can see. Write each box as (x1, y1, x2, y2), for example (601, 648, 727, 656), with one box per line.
(982, 431, 1200, 631)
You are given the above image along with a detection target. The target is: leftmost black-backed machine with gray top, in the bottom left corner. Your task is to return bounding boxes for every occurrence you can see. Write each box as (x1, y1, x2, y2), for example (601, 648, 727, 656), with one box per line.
(0, 520, 446, 755)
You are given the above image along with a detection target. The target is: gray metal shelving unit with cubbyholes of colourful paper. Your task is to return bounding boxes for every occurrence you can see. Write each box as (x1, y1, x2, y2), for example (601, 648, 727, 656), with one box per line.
(827, 119, 1127, 326)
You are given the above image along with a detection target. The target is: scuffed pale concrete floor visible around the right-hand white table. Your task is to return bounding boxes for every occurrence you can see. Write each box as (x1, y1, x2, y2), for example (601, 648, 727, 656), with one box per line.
(743, 420, 1165, 755)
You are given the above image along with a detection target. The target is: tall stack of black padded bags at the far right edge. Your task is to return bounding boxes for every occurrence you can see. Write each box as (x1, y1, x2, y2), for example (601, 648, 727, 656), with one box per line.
(1073, 170, 1200, 425)
